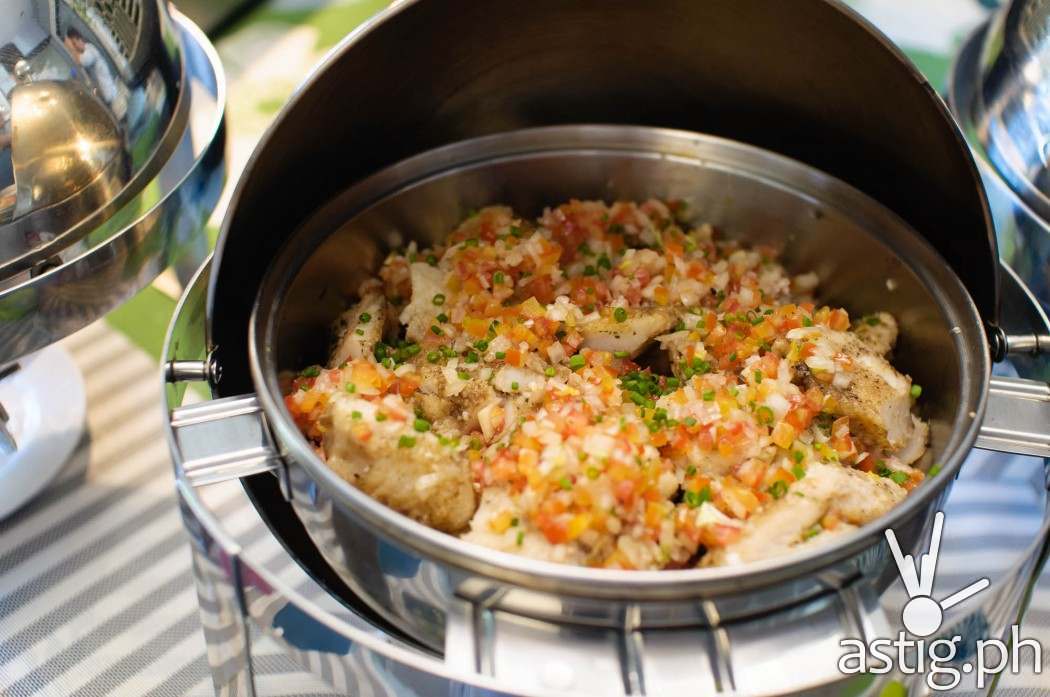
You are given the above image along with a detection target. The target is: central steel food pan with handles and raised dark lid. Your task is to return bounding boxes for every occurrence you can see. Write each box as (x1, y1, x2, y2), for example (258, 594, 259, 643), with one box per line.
(161, 0, 1050, 691)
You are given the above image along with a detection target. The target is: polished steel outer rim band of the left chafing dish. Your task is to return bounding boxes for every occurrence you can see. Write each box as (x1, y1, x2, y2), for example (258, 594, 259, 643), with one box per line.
(0, 5, 226, 362)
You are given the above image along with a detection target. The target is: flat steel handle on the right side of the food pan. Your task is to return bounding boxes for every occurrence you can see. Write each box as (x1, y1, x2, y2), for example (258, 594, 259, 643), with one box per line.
(974, 376, 1050, 458)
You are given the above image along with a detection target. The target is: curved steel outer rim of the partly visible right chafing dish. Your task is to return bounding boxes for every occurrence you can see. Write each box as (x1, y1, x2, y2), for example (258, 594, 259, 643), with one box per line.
(948, 24, 1050, 309)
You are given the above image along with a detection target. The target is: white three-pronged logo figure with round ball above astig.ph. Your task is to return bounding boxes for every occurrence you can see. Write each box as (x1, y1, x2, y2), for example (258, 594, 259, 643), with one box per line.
(886, 511, 991, 636)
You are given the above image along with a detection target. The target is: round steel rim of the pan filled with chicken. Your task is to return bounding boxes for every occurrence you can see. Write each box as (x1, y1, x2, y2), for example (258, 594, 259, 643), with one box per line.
(248, 125, 990, 599)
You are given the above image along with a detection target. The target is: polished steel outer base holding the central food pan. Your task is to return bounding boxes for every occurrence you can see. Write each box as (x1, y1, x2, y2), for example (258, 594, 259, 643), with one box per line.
(164, 256, 1050, 697)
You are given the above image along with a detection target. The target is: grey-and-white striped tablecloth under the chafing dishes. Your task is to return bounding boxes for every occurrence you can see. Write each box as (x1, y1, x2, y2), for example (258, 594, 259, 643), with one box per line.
(0, 0, 1050, 697)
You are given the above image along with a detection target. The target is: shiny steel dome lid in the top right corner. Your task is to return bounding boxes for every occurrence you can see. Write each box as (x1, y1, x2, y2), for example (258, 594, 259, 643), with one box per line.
(968, 0, 1050, 219)
